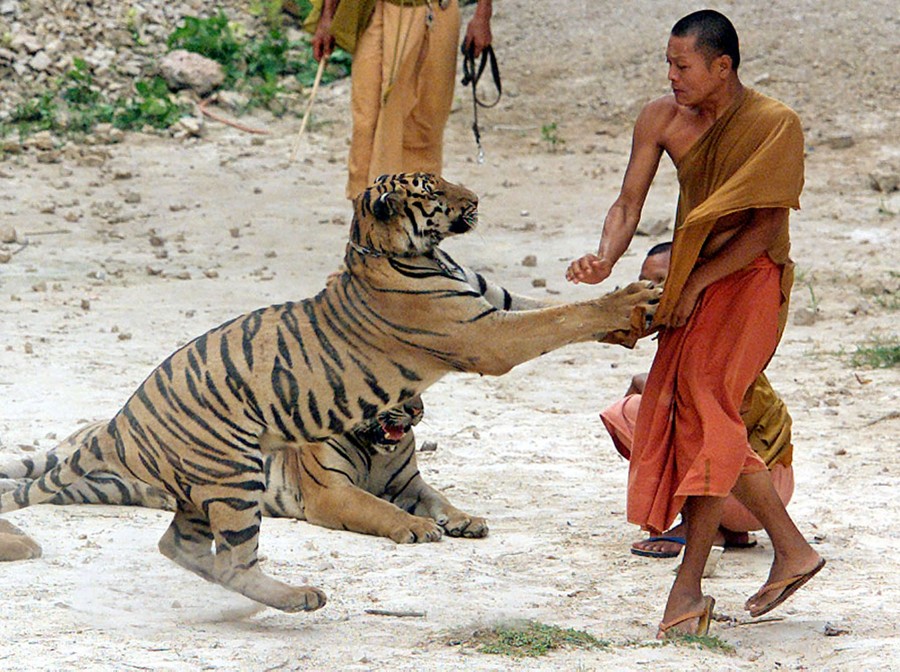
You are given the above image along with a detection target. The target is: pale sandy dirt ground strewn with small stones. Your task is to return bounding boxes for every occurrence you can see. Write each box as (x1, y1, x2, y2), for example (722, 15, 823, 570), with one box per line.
(0, 0, 900, 670)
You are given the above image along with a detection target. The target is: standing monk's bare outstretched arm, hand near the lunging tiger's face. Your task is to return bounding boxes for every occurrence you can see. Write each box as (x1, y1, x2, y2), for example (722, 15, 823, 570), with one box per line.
(566, 101, 668, 285)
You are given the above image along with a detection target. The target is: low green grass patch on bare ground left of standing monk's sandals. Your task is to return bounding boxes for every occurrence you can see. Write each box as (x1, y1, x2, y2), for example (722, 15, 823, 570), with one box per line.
(475, 621, 609, 657)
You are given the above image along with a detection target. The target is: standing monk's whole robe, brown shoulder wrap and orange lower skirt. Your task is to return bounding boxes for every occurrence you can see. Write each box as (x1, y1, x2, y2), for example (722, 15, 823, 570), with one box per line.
(627, 89, 803, 532)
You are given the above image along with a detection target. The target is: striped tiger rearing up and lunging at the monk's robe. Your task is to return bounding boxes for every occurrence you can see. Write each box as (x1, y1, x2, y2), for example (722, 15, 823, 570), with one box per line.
(0, 173, 660, 612)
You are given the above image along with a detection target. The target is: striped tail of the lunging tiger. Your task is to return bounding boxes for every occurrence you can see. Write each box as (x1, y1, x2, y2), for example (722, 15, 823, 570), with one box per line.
(0, 432, 112, 513)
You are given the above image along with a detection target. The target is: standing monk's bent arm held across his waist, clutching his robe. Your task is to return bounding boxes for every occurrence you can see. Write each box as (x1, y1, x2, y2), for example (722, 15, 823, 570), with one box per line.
(669, 208, 788, 327)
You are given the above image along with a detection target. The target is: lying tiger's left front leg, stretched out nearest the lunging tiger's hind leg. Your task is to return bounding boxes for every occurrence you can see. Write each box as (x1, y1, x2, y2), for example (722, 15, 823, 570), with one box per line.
(300, 444, 442, 544)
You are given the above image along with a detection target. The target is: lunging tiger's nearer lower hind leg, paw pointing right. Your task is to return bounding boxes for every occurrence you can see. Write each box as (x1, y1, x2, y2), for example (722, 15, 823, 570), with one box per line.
(207, 498, 325, 612)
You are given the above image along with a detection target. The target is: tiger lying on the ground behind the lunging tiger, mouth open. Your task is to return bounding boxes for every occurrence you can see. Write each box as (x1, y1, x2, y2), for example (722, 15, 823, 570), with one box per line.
(0, 397, 488, 548)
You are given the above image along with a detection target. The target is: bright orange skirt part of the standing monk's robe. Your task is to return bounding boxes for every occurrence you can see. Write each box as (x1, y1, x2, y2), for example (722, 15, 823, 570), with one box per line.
(628, 254, 782, 532)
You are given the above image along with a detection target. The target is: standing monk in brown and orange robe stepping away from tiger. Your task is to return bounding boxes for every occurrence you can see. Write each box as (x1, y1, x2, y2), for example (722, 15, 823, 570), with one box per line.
(566, 10, 824, 637)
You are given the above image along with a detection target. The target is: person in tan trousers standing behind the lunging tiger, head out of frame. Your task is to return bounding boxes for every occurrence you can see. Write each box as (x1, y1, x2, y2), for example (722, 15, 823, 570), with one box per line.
(312, 0, 492, 199)
